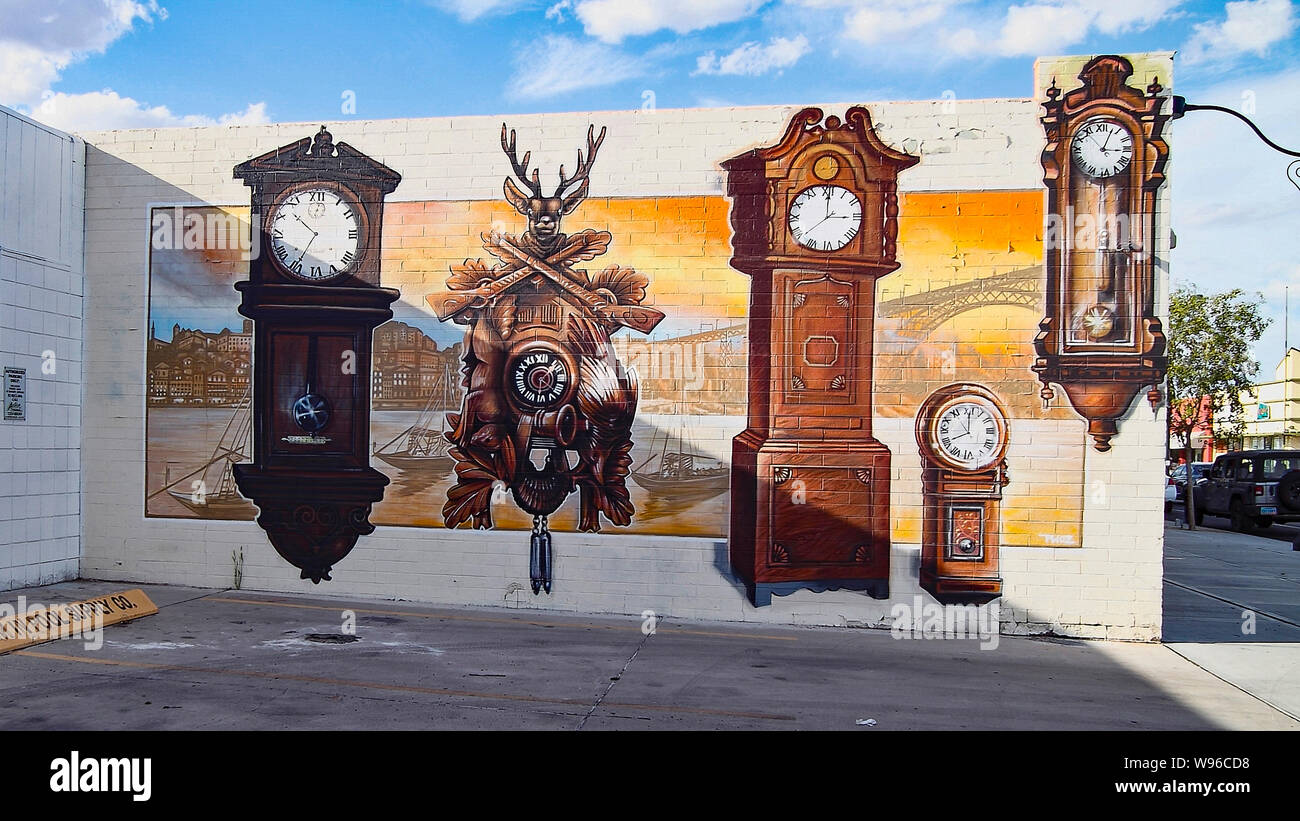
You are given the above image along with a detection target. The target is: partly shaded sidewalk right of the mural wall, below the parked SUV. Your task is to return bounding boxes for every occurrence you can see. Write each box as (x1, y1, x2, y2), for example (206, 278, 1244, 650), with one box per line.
(1164, 518, 1300, 717)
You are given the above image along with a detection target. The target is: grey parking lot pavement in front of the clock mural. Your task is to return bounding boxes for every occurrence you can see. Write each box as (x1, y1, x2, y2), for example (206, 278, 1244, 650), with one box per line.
(0, 582, 1300, 733)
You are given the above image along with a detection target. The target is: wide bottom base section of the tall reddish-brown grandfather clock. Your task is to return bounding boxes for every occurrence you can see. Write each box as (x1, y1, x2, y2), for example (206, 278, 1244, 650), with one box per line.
(731, 431, 891, 607)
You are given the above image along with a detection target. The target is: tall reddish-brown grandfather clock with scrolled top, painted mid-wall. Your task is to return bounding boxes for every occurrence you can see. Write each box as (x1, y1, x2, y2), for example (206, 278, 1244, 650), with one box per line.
(723, 107, 918, 604)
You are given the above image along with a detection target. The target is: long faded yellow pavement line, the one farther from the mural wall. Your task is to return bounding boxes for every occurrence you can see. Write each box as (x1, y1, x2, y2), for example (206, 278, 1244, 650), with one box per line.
(12, 650, 794, 721)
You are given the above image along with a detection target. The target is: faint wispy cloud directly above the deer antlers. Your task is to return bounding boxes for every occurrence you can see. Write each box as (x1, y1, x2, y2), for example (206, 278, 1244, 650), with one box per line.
(507, 35, 646, 99)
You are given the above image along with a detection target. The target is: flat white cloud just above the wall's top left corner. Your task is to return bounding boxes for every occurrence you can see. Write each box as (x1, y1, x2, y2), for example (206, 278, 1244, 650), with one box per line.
(30, 88, 270, 131)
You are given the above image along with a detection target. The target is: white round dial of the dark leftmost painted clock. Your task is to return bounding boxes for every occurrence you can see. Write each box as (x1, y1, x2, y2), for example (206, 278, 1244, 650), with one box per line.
(267, 188, 361, 281)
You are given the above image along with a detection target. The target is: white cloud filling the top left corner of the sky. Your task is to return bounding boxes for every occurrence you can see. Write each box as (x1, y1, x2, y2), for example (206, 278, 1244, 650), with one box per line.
(0, 0, 166, 107)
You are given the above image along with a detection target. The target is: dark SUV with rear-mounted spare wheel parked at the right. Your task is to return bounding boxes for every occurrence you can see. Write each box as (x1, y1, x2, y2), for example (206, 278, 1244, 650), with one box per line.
(1193, 451, 1300, 531)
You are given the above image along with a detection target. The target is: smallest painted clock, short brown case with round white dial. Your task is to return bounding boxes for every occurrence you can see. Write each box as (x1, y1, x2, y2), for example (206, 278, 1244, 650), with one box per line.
(917, 385, 1010, 604)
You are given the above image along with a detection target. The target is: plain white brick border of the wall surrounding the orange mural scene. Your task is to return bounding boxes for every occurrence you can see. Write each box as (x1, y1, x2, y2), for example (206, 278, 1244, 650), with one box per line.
(73, 68, 1167, 639)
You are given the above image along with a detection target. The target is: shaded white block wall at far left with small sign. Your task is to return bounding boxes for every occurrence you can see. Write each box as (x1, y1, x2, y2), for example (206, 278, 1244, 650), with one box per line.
(0, 108, 86, 590)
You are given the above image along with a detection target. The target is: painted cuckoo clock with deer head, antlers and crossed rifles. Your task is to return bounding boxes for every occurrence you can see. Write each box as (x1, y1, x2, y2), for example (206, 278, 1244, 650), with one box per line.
(429, 125, 664, 594)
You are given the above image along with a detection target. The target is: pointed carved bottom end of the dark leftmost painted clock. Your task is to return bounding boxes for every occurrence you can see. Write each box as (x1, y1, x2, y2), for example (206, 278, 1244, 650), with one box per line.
(233, 464, 389, 585)
